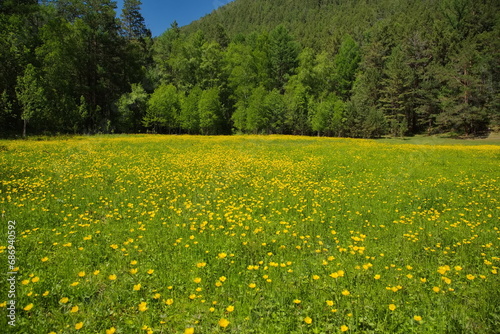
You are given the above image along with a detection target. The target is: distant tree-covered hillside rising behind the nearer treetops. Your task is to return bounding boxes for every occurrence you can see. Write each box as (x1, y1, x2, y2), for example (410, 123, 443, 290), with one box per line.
(183, 0, 432, 49)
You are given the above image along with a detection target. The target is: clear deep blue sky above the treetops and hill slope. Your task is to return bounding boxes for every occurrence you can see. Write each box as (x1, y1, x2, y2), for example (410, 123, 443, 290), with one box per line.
(116, 0, 231, 36)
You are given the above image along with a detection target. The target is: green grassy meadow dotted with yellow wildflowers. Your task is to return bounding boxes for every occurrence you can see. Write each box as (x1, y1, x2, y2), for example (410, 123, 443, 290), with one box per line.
(0, 135, 500, 334)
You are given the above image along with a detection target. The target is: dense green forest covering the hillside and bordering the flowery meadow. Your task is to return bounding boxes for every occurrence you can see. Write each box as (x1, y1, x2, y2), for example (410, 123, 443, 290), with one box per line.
(0, 0, 500, 138)
